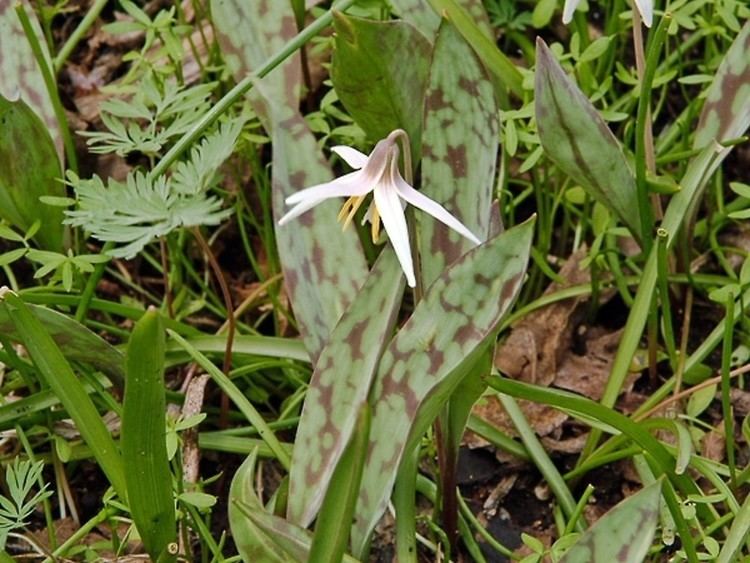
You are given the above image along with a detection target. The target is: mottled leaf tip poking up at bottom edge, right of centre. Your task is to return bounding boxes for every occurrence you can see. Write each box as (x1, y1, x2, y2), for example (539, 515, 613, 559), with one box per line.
(560, 480, 661, 563)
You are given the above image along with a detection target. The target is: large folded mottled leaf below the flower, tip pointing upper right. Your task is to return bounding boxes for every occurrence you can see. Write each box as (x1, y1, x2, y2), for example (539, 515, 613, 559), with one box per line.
(352, 220, 534, 555)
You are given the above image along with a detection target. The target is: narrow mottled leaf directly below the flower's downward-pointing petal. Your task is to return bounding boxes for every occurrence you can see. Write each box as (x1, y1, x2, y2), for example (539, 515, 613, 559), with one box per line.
(287, 251, 404, 527)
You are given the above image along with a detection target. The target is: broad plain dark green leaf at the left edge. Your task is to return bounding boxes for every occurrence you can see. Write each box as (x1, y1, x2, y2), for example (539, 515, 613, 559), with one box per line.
(0, 96, 65, 252)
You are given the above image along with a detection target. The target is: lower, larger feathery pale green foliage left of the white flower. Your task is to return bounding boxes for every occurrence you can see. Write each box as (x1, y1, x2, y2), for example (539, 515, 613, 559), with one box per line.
(65, 120, 244, 259)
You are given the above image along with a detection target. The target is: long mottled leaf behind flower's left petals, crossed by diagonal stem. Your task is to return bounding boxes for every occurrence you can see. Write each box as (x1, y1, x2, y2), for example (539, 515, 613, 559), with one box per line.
(211, 0, 367, 361)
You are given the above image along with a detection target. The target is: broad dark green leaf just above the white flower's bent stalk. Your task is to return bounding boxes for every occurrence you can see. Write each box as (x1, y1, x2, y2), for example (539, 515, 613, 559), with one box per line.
(331, 13, 430, 155)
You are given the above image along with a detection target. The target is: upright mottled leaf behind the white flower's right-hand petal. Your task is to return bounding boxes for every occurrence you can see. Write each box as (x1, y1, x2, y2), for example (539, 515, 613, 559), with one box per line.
(420, 22, 499, 285)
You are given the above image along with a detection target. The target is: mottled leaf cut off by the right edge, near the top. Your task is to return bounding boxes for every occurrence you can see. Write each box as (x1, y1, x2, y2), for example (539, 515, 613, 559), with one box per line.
(693, 21, 750, 148)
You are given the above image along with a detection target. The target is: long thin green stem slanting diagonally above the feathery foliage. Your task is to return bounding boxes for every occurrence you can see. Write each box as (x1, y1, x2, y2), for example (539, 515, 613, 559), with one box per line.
(150, 0, 355, 178)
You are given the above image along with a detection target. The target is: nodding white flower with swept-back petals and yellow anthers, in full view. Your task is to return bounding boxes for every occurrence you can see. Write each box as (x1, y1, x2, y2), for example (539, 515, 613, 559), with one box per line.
(279, 129, 481, 287)
